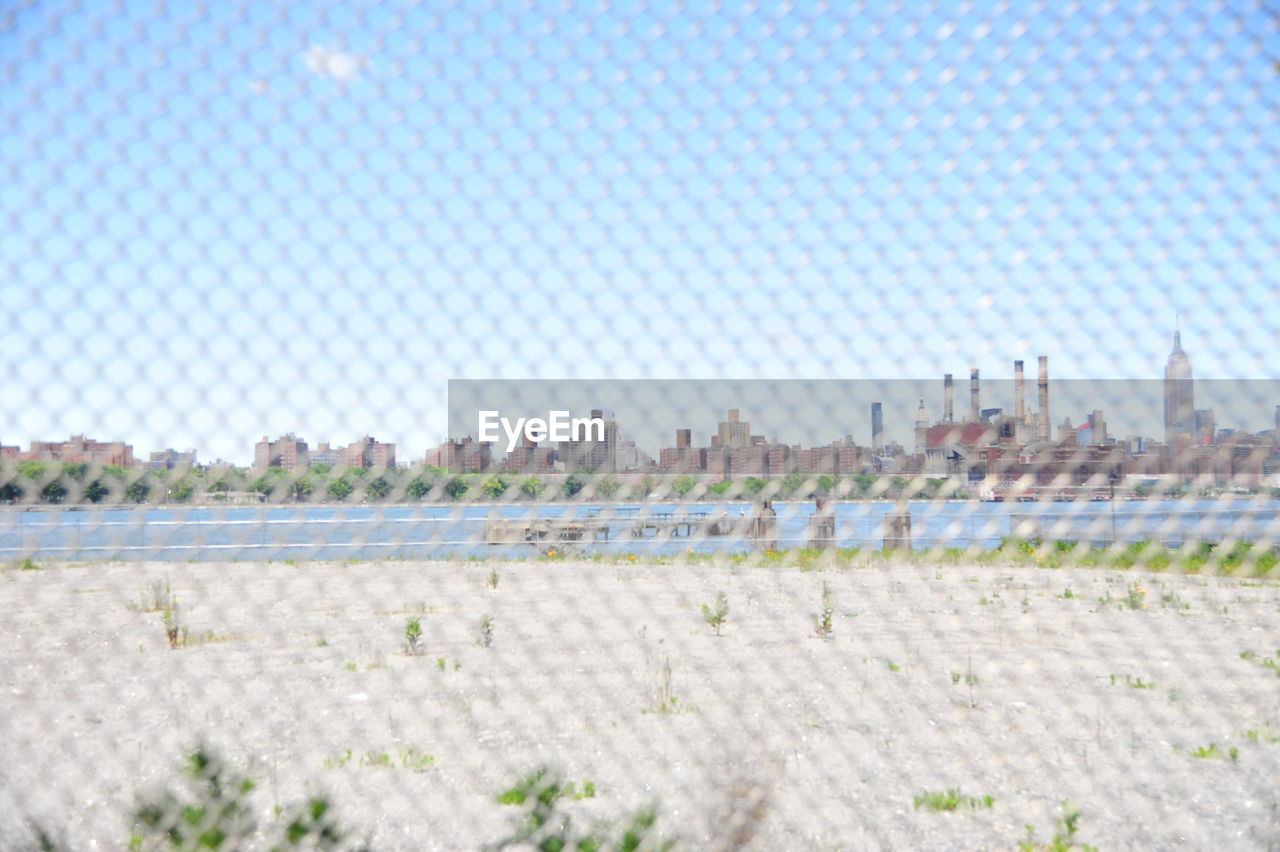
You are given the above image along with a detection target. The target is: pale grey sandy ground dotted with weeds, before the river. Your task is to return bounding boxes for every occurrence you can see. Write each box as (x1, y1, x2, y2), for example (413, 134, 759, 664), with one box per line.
(0, 562, 1280, 849)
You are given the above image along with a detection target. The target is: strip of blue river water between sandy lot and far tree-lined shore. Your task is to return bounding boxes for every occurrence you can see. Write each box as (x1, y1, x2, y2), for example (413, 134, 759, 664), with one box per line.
(0, 500, 1280, 562)
